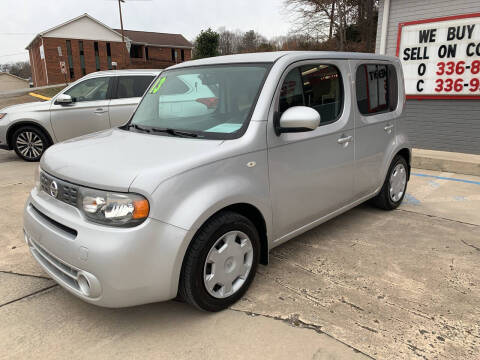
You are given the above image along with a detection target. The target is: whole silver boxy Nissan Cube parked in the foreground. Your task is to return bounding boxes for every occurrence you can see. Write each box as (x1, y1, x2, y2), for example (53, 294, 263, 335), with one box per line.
(24, 52, 411, 311)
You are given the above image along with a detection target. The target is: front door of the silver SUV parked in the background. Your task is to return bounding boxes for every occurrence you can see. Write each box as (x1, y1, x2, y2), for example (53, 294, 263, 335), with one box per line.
(50, 77, 111, 141)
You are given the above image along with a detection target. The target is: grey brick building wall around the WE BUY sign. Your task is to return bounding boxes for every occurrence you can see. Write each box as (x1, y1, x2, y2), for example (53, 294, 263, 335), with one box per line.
(376, 0, 480, 154)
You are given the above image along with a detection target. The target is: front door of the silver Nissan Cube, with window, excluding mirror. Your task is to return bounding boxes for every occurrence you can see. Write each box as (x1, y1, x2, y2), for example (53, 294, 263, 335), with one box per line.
(268, 61, 355, 239)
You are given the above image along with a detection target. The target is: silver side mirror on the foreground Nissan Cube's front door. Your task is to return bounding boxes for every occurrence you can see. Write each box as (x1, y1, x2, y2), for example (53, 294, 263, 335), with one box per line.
(275, 106, 320, 135)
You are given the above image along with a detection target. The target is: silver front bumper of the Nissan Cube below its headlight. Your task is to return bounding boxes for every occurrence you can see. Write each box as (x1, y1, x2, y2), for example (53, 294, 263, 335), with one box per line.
(24, 188, 187, 307)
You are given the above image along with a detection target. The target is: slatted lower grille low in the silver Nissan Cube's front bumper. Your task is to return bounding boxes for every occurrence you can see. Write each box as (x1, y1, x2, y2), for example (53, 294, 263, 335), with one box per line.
(28, 238, 80, 291)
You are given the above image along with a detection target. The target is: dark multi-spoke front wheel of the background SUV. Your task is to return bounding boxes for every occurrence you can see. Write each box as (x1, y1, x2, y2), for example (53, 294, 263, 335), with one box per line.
(12, 126, 50, 161)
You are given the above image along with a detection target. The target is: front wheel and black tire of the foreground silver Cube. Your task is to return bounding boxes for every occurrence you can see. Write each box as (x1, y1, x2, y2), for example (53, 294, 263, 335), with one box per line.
(179, 211, 260, 311)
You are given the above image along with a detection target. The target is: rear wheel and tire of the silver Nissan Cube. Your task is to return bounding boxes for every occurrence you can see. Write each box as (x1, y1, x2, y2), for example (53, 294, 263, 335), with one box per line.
(372, 155, 408, 210)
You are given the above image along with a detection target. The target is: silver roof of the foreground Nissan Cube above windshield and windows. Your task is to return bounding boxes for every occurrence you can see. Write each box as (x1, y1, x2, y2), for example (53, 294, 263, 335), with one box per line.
(168, 51, 398, 69)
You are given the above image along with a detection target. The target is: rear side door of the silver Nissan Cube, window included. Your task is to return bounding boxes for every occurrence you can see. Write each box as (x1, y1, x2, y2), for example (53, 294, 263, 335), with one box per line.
(351, 60, 398, 198)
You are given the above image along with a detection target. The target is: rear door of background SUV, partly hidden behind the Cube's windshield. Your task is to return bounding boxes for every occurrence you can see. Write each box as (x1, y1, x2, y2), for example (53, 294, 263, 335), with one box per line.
(109, 75, 154, 127)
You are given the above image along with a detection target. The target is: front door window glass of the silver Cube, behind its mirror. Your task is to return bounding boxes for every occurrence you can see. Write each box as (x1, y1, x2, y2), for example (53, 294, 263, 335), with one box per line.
(279, 65, 343, 126)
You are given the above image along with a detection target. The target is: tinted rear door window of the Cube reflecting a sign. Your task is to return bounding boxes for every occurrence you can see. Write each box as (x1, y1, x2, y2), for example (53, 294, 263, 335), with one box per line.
(356, 64, 398, 115)
